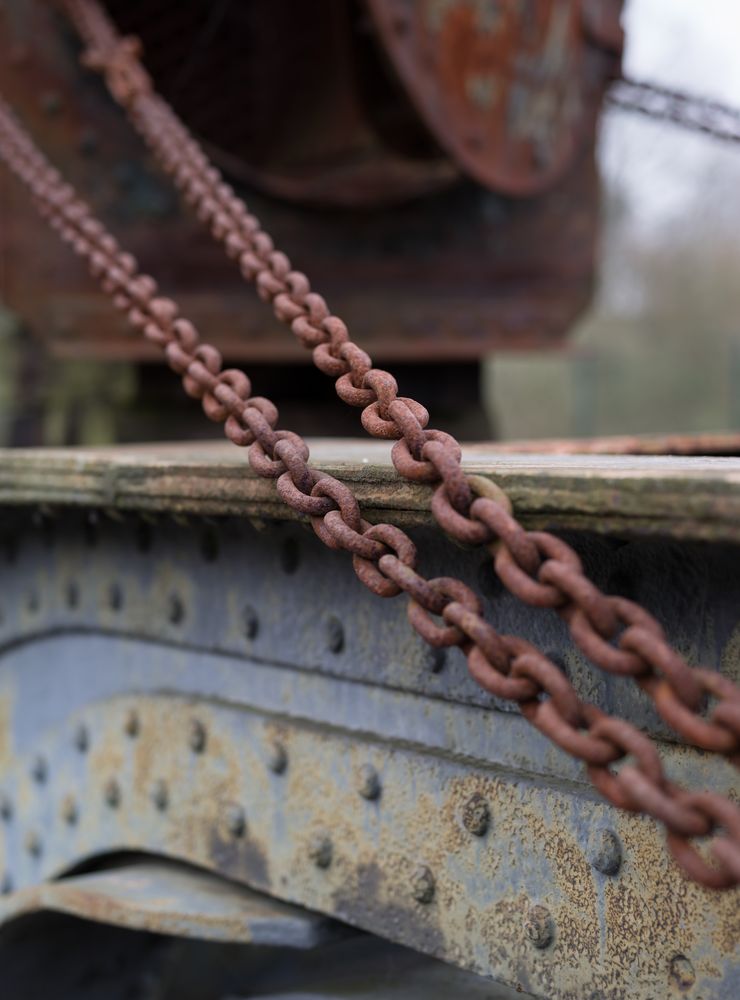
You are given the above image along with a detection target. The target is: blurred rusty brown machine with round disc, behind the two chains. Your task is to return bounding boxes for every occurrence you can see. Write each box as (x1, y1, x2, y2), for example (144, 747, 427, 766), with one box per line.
(0, 0, 621, 443)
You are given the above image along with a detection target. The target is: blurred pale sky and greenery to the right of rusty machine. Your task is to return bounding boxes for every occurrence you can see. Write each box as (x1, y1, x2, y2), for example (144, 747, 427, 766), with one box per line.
(486, 0, 740, 438)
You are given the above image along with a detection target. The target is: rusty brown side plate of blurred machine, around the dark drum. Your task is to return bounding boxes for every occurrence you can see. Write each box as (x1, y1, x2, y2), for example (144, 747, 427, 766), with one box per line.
(0, 0, 598, 372)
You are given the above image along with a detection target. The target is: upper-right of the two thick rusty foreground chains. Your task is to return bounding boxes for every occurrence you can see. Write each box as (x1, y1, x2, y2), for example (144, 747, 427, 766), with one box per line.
(57, 0, 740, 764)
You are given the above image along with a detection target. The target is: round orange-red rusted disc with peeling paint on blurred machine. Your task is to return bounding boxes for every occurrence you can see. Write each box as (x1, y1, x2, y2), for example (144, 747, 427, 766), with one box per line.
(368, 0, 620, 195)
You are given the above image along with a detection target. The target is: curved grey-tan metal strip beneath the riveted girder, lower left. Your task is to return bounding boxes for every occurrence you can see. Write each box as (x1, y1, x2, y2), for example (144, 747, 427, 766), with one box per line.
(0, 860, 332, 948)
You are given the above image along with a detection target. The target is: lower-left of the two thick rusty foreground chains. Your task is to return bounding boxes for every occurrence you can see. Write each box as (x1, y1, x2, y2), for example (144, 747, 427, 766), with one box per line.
(0, 92, 740, 888)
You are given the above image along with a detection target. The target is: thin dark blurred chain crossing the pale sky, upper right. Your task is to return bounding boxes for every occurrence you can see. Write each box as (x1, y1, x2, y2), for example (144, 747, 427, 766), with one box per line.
(606, 79, 740, 142)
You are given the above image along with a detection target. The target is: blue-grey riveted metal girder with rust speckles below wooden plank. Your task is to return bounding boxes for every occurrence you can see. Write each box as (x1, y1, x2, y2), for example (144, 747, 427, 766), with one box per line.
(0, 511, 740, 1000)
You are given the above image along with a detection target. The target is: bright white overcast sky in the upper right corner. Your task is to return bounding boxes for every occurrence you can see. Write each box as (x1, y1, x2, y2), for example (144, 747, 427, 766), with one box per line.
(600, 0, 740, 230)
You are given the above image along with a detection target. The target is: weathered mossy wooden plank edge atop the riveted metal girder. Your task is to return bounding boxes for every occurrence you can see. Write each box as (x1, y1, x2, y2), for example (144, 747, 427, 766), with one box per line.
(0, 439, 740, 542)
